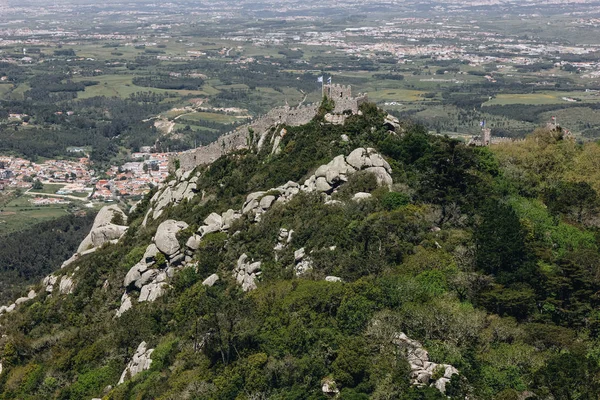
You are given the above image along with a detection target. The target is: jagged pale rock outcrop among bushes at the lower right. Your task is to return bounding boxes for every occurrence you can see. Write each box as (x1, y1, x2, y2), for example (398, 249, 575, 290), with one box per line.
(394, 333, 459, 393)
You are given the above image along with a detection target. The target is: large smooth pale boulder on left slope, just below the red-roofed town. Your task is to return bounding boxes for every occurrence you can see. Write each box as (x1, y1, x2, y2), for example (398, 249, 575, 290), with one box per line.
(77, 205, 127, 253)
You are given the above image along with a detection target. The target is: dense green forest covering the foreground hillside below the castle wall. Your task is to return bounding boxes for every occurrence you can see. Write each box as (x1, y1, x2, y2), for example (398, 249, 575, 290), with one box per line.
(0, 104, 600, 400)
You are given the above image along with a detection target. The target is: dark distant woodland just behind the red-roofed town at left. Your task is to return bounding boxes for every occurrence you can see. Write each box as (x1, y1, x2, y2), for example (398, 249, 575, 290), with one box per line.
(0, 93, 168, 165)
